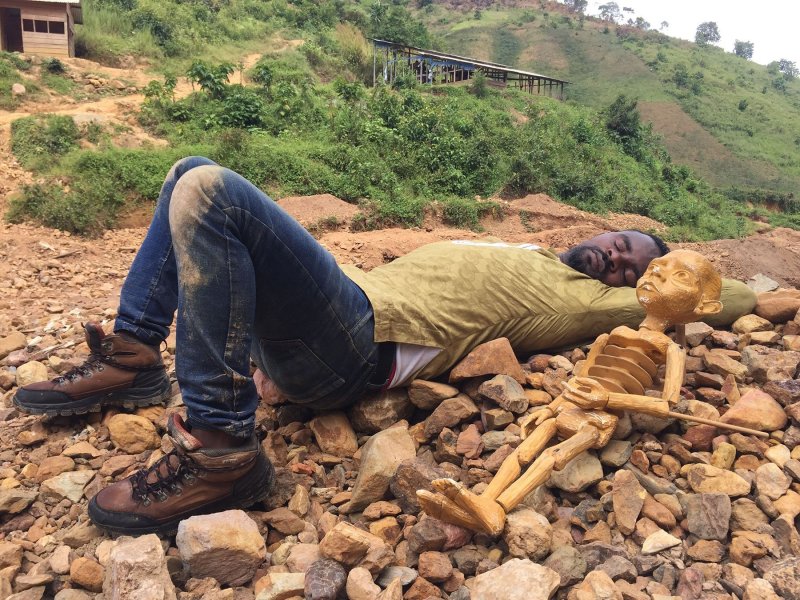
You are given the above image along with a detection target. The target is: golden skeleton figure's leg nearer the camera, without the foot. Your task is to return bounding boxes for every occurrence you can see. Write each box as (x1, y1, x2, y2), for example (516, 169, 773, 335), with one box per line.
(497, 424, 601, 512)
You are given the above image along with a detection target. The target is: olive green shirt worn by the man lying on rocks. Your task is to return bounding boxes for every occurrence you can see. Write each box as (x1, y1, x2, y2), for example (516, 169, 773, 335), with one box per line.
(343, 241, 756, 378)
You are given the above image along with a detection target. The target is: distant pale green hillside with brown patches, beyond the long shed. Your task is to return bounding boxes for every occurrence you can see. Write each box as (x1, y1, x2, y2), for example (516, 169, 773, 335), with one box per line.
(419, 3, 800, 192)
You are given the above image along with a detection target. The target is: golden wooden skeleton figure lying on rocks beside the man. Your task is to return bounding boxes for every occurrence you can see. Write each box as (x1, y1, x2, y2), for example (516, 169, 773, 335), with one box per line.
(417, 250, 765, 535)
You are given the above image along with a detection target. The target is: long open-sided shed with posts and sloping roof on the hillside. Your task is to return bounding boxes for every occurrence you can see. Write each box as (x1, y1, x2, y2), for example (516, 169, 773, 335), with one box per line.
(372, 38, 569, 100)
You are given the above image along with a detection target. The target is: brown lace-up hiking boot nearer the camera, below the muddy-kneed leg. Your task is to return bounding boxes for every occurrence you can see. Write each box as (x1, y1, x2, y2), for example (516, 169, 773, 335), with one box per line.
(89, 414, 275, 535)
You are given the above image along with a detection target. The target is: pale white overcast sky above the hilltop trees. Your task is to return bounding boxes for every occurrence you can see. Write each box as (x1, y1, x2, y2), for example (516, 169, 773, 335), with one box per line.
(587, 0, 800, 65)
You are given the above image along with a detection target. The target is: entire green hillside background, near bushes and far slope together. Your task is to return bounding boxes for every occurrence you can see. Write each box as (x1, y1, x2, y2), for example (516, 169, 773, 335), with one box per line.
(6, 0, 800, 240)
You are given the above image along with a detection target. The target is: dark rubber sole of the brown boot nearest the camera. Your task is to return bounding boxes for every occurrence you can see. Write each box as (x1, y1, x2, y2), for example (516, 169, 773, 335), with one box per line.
(89, 451, 275, 537)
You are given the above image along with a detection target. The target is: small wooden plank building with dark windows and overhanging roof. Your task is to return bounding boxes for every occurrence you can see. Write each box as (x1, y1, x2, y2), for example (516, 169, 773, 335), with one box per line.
(0, 0, 82, 57)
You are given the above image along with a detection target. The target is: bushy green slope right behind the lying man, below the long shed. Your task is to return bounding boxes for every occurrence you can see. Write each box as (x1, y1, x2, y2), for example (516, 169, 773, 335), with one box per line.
(3, 0, 795, 240)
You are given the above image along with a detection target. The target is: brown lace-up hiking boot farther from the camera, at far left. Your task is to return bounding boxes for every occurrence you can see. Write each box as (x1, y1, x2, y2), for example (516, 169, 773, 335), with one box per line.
(14, 323, 170, 416)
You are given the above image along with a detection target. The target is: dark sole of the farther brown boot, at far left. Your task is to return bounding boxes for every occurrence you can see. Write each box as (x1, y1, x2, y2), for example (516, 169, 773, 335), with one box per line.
(13, 375, 172, 417)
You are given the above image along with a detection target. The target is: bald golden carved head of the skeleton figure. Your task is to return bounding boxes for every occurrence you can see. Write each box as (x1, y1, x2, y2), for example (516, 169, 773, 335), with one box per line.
(636, 250, 722, 324)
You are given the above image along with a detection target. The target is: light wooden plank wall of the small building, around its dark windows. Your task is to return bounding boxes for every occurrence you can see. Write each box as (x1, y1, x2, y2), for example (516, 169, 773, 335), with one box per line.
(0, 0, 70, 57)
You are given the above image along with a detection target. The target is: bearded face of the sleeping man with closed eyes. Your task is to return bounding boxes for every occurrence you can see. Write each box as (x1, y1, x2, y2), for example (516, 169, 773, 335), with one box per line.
(559, 229, 669, 287)
